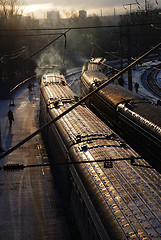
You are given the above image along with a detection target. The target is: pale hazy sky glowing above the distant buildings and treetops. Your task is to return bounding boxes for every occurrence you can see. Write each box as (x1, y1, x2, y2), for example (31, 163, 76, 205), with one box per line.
(24, 0, 161, 17)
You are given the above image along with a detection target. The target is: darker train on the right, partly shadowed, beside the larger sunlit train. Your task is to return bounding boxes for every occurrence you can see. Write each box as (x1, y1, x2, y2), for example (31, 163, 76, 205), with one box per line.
(81, 59, 161, 168)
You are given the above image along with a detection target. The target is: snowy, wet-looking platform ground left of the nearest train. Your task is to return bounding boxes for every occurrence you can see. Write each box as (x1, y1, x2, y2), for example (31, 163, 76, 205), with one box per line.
(0, 82, 70, 240)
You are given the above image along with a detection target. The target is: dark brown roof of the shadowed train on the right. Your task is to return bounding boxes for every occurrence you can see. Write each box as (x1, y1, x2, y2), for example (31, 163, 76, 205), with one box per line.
(83, 71, 161, 127)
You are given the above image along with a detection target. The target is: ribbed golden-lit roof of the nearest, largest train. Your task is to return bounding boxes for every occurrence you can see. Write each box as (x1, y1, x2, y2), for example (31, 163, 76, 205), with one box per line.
(40, 78, 161, 239)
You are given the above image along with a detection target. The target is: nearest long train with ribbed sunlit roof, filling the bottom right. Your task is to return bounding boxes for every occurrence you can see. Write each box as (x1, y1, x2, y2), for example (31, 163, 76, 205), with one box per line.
(40, 74, 161, 240)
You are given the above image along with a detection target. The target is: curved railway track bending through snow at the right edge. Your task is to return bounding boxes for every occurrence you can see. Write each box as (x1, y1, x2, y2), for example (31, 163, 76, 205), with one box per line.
(145, 65, 161, 98)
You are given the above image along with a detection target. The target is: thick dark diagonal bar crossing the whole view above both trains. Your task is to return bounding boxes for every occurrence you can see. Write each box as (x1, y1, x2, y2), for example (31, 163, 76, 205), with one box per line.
(0, 42, 161, 159)
